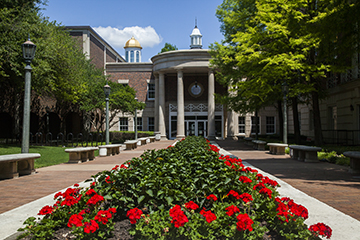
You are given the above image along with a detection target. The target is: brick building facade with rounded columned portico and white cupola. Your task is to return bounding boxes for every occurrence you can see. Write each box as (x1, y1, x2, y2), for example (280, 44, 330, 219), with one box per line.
(106, 26, 278, 139)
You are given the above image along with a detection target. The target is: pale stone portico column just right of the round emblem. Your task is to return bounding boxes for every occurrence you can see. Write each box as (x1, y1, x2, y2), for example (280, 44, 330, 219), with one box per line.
(208, 71, 215, 140)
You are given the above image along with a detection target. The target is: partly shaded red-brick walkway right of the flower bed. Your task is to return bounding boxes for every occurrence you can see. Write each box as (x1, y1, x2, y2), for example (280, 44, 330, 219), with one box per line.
(217, 140, 360, 220)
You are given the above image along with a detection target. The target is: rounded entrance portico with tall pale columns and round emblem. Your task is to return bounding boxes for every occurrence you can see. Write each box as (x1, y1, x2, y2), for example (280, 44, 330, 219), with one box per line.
(151, 49, 223, 139)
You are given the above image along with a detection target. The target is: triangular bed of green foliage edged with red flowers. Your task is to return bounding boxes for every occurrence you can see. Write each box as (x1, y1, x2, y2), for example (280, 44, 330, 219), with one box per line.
(18, 137, 331, 239)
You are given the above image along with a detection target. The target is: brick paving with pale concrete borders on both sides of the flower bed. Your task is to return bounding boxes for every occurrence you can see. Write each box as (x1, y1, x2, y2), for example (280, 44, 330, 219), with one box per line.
(0, 140, 360, 240)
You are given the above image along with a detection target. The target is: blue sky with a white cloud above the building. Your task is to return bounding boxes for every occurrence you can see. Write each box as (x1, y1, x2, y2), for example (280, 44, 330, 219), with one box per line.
(42, 0, 223, 62)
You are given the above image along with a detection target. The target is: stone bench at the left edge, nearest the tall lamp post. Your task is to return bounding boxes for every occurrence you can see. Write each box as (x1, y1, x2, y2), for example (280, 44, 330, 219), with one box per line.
(0, 153, 41, 179)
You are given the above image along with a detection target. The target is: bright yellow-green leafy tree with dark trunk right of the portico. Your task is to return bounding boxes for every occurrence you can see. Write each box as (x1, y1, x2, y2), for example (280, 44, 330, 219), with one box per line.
(211, 0, 356, 145)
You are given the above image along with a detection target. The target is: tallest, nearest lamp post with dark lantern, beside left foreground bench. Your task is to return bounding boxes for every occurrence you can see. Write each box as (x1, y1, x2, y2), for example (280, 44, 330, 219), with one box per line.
(21, 35, 36, 153)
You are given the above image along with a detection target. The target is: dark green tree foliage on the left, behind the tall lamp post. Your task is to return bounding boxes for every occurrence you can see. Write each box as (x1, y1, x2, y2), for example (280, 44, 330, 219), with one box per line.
(0, 0, 143, 135)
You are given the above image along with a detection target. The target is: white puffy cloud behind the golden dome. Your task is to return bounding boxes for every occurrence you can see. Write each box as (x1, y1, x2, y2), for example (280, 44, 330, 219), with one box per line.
(94, 26, 162, 48)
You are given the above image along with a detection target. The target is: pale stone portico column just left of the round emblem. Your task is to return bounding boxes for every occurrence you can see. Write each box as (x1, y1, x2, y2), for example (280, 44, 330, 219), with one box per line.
(176, 70, 185, 140)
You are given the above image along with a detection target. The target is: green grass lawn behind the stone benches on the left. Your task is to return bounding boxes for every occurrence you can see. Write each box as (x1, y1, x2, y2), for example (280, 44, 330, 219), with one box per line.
(0, 144, 99, 169)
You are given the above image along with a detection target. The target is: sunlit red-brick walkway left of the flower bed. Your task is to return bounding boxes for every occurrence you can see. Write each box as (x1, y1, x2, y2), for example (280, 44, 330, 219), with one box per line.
(0, 140, 174, 214)
